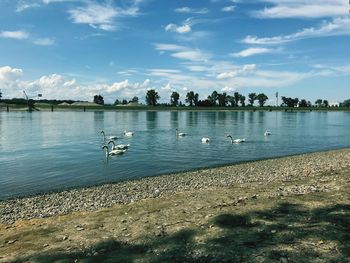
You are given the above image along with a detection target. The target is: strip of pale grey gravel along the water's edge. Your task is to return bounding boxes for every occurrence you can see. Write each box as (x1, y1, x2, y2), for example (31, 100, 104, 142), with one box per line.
(0, 149, 350, 224)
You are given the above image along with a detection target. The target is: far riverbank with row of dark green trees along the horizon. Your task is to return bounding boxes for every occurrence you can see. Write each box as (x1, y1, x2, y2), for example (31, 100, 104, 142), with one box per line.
(0, 89, 350, 111)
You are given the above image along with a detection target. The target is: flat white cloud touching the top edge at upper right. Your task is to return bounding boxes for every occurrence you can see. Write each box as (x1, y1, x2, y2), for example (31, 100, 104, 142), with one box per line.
(253, 0, 349, 18)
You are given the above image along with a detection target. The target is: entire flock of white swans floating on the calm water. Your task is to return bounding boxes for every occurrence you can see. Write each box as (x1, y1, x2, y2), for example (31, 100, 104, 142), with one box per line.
(101, 129, 271, 157)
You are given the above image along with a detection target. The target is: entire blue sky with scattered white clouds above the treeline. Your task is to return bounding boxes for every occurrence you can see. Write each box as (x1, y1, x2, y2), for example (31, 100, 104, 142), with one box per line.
(0, 0, 350, 105)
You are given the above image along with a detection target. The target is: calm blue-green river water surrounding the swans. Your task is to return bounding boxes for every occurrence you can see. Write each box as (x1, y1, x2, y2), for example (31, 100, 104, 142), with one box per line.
(0, 112, 350, 199)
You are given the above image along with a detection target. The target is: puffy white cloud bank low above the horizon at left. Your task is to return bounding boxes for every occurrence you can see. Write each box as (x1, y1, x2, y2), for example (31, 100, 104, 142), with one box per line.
(0, 66, 150, 102)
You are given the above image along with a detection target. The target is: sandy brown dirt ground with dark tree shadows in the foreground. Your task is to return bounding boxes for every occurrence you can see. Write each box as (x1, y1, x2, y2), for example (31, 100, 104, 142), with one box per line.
(0, 170, 350, 263)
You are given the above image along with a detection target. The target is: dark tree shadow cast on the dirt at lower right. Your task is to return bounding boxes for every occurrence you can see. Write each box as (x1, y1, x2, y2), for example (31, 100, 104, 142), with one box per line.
(12, 203, 350, 262)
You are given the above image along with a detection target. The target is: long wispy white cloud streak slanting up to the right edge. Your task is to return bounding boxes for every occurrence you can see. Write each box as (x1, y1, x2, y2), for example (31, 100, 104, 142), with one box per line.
(243, 18, 350, 45)
